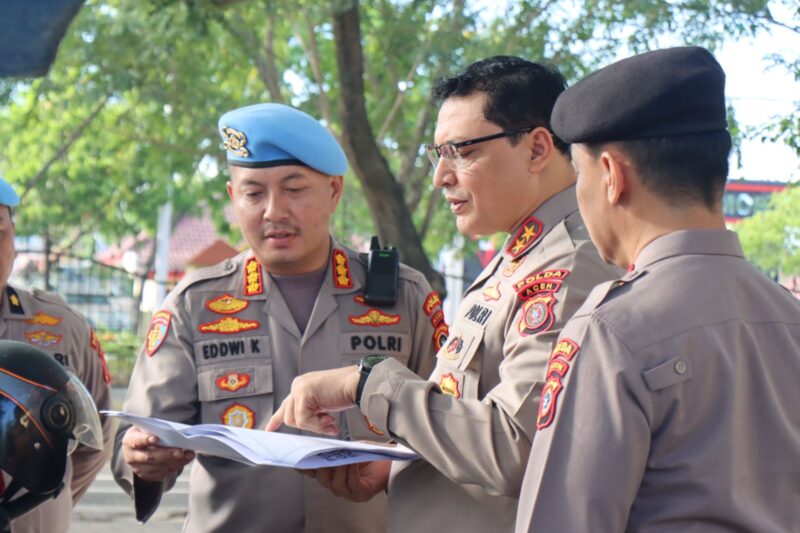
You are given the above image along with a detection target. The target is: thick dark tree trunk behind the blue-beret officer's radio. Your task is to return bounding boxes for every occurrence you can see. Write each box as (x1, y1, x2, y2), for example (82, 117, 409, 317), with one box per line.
(333, 0, 444, 291)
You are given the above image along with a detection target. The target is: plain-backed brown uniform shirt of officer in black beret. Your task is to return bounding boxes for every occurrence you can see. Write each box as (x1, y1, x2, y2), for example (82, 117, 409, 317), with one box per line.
(517, 230, 800, 533)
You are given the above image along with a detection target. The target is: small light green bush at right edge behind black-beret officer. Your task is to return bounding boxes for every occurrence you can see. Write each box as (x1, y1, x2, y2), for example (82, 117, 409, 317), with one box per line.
(734, 184, 800, 276)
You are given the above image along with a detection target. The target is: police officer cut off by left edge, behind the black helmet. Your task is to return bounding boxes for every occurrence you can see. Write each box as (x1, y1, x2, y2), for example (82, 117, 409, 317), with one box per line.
(0, 178, 111, 533)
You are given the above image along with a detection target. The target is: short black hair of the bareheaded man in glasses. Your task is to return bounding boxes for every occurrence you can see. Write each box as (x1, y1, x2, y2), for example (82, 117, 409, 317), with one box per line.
(433, 56, 569, 156)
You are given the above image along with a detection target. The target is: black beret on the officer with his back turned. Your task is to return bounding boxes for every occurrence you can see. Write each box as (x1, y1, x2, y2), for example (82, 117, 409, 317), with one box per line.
(551, 46, 727, 143)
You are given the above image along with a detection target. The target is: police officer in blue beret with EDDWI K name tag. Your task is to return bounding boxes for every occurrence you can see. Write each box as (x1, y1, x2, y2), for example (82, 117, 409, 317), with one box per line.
(113, 104, 438, 533)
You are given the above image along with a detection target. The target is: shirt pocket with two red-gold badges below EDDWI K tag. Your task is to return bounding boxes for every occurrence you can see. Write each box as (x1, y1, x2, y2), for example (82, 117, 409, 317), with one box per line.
(197, 360, 275, 429)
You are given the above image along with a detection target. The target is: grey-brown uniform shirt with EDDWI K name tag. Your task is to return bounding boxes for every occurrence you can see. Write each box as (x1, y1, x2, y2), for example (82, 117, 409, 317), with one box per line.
(112, 244, 435, 533)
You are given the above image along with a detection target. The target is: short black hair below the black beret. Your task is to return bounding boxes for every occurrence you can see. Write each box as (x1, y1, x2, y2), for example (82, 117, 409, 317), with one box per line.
(584, 130, 731, 209)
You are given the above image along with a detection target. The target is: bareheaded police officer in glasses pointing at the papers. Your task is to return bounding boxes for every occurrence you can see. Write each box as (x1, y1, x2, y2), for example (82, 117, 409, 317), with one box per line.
(269, 57, 616, 533)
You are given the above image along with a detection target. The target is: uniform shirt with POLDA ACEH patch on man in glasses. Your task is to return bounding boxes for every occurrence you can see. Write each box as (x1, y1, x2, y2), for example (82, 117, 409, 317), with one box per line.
(361, 187, 618, 533)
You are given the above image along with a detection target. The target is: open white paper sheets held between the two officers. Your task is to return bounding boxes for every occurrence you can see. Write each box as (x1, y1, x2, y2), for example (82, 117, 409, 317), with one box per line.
(101, 411, 419, 468)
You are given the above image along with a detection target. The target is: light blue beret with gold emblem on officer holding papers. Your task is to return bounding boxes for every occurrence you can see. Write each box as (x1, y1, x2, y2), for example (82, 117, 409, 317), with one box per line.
(219, 104, 347, 176)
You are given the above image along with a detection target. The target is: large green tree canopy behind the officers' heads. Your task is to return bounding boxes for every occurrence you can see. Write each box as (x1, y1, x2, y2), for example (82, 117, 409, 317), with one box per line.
(0, 0, 800, 264)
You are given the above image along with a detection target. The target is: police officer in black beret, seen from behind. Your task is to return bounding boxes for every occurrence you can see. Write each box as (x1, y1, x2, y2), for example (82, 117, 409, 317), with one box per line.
(517, 47, 800, 532)
